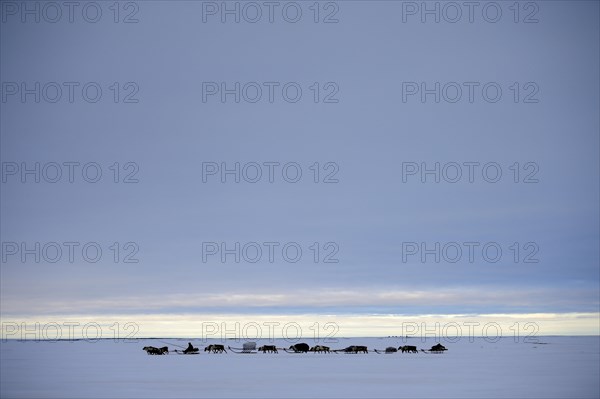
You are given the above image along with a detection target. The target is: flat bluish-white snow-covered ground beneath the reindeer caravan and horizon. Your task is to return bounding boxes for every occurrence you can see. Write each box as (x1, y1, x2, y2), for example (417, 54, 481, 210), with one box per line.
(0, 337, 600, 398)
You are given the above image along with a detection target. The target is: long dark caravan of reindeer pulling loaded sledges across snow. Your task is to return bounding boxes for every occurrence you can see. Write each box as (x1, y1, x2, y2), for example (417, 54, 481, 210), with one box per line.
(143, 342, 448, 355)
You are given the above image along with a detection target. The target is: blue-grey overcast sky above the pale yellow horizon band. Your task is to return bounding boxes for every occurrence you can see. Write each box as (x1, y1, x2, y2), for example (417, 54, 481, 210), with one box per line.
(0, 1, 600, 334)
